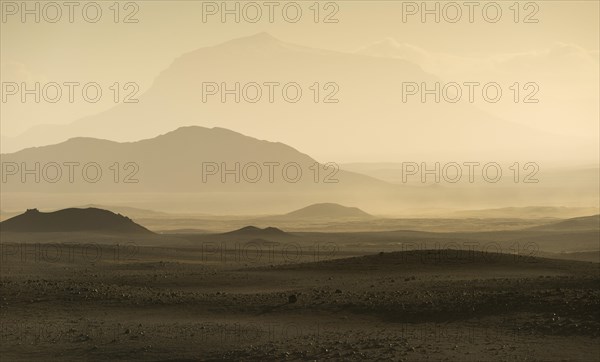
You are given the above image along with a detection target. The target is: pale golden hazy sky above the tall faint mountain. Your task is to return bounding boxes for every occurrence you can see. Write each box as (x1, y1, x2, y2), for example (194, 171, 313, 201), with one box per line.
(0, 1, 600, 161)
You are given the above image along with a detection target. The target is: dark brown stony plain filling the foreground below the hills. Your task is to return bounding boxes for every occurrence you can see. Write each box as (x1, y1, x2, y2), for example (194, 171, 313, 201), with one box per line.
(0, 245, 600, 361)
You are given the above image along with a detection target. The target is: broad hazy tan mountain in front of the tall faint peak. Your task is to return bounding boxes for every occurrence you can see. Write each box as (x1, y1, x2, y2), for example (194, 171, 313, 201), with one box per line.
(1, 126, 390, 193)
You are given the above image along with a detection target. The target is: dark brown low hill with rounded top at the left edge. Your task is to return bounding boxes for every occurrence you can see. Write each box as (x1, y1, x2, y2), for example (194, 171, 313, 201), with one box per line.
(0, 208, 152, 234)
